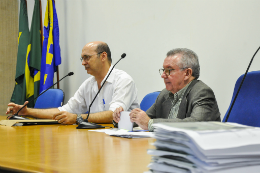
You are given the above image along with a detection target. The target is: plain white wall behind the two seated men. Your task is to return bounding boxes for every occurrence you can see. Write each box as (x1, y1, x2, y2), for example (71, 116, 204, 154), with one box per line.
(27, 0, 260, 118)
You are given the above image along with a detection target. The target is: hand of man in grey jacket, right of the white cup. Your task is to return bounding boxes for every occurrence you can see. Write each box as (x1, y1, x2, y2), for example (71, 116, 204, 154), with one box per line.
(129, 108, 150, 130)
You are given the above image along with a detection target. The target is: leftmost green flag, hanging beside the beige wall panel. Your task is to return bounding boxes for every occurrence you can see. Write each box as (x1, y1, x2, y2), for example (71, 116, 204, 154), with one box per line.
(11, 0, 29, 104)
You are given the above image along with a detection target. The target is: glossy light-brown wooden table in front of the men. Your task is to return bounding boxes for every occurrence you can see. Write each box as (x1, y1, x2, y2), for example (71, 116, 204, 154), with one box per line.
(0, 116, 155, 173)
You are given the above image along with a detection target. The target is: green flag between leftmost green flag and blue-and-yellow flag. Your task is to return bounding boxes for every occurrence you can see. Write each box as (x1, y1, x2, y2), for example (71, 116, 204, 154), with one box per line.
(29, 0, 42, 104)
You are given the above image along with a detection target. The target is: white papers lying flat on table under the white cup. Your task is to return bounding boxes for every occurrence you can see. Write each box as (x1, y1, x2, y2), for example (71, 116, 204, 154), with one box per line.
(89, 128, 153, 138)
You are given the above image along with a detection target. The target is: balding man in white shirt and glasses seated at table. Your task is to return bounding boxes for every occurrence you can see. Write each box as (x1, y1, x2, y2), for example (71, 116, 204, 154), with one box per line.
(6, 41, 139, 124)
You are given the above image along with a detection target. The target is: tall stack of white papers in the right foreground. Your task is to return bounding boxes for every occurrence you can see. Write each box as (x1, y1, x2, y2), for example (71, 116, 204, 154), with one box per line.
(148, 122, 260, 173)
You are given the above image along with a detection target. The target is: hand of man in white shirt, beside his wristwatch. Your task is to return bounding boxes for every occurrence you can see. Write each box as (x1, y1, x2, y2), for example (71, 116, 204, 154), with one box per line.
(52, 111, 77, 124)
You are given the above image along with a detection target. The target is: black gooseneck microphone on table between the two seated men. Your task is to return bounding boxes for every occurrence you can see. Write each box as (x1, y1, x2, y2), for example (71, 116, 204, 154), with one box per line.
(77, 53, 126, 129)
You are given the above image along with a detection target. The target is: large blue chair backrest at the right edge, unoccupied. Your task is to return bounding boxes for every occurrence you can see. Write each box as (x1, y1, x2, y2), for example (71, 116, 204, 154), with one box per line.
(223, 71, 260, 127)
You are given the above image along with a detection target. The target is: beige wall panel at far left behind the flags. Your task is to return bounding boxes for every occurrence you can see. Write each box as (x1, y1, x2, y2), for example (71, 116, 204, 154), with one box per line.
(0, 0, 18, 115)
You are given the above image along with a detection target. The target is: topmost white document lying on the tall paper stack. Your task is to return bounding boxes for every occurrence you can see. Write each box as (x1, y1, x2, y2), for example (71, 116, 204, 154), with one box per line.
(154, 122, 260, 151)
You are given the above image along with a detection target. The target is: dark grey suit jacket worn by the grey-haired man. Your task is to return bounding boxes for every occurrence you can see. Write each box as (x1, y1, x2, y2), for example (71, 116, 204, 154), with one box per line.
(146, 80, 221, 123)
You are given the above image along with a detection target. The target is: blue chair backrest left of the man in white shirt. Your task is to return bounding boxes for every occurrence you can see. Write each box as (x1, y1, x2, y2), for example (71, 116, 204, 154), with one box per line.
(34, 89, 65, 109)
